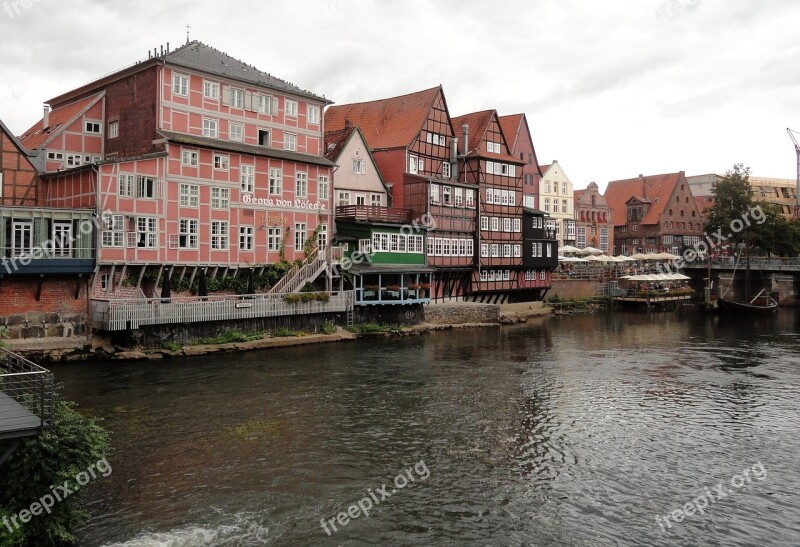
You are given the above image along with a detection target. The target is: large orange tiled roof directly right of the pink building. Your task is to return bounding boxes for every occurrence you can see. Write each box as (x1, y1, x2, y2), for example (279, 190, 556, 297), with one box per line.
(325, 86, 444, 150)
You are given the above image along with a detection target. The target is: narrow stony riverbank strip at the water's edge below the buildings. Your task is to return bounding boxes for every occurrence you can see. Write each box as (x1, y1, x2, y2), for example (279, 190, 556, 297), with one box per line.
(6, 302, 553, 363)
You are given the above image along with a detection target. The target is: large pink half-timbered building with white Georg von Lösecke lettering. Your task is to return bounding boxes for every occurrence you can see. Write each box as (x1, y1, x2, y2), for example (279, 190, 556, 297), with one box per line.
(21, 42, 334, 296)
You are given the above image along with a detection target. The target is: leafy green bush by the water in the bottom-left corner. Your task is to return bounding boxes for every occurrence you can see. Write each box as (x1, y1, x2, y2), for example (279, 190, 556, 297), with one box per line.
(0, 392, 110, 547)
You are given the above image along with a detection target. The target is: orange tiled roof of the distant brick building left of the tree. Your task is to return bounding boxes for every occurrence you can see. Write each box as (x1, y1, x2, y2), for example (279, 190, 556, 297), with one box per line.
(605, 171, 683, 226)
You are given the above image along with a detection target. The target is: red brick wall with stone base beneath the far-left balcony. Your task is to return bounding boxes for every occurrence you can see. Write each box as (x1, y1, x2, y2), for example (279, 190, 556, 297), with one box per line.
(0, 276, 89, 339)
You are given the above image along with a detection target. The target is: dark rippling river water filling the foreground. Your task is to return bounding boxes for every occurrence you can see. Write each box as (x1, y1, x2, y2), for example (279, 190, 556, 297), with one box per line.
(54, 311, 800, 546)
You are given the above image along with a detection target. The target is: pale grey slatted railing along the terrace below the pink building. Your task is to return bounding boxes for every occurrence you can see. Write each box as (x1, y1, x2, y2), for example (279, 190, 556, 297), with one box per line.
(92, 291, 353, 331)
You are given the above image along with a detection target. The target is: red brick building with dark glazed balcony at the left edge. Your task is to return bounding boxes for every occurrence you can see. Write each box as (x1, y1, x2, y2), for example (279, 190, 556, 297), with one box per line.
(0, 121, 95, 338)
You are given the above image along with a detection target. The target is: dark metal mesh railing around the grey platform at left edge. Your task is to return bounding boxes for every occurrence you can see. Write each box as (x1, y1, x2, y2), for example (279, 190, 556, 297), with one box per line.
(0, 348, 55, 438)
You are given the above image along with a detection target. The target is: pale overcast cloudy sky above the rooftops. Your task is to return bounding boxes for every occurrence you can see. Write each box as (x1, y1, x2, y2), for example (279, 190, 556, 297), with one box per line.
(0, 0, 800, 188)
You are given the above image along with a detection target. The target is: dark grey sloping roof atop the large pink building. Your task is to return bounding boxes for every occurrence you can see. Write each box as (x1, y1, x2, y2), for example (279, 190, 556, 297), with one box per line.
(161, 40, 332, 104)
